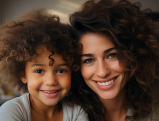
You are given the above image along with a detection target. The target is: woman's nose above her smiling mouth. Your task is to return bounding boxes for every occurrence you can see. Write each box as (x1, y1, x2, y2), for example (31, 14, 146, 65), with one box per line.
(97, 61, 111, 78)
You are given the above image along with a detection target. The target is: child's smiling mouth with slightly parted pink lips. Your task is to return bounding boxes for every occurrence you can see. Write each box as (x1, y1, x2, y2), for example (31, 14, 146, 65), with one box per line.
(40, 90, 61, 98)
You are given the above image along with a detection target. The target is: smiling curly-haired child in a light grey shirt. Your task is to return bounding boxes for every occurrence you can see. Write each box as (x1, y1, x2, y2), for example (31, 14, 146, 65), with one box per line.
(0, 10, 88, 121)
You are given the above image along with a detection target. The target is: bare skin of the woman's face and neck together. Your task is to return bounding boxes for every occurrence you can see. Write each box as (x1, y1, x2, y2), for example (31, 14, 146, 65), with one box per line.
(79, 33, 128, 121)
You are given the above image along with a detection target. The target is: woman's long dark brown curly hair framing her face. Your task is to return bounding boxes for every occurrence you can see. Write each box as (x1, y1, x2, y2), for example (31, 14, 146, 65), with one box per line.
(70, 0, 159, 121)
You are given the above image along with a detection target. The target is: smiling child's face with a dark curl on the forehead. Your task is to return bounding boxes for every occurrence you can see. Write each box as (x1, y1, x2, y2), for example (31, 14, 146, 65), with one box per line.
(21, 46, 71, 106)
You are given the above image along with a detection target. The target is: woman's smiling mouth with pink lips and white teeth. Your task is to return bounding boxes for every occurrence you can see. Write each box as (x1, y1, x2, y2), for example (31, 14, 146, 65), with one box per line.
(94, 76, 118, 90)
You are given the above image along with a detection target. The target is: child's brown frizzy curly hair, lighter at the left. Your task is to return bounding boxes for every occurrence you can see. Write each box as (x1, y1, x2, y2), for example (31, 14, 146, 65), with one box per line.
(0, 9, 79, 92)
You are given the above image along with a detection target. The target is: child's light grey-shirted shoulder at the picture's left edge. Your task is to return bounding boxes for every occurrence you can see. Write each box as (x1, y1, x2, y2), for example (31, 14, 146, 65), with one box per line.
(0, 93, 31, 121)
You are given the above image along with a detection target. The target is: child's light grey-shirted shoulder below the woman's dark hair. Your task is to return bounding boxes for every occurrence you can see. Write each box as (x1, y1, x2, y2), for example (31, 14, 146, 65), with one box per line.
(61, 100, 89, 121)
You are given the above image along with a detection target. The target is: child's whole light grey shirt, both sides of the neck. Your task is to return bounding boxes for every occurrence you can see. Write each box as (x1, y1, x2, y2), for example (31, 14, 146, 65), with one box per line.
(0, 93, 89, 121)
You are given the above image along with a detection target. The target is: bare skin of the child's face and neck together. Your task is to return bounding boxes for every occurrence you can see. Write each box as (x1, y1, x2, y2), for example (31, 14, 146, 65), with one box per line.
(21, 46, 71, 121)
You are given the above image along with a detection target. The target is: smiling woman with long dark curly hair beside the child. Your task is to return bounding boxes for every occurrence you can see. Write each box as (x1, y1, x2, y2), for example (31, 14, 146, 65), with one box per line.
(70, 0, 159, 121)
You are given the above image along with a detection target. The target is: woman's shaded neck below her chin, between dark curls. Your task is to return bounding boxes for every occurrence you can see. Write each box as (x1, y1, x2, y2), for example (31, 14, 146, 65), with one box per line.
(99, 88, 128, 121)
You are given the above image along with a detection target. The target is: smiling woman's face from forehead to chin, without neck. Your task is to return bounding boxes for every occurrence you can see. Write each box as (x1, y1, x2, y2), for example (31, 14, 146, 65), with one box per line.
(80, 33, 128, 99)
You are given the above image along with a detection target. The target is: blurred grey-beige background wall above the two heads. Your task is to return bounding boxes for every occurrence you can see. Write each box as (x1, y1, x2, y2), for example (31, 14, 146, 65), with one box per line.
(0, 0, 159, 25)
